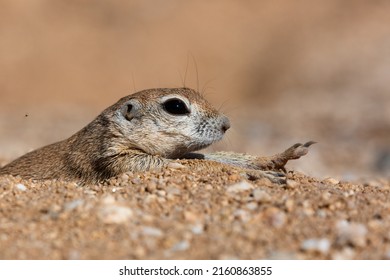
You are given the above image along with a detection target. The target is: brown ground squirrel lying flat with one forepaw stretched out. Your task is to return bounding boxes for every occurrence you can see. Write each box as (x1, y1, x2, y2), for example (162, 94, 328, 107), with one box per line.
(0, 88, 314, 183)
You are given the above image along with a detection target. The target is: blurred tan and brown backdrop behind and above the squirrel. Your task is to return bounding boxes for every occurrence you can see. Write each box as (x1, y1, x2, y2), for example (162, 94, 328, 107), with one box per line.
(0, 0, 390, 179)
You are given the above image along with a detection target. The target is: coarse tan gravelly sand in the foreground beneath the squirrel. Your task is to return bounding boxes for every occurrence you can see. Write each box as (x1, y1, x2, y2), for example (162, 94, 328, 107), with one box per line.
(0, 164, 390, 259)
